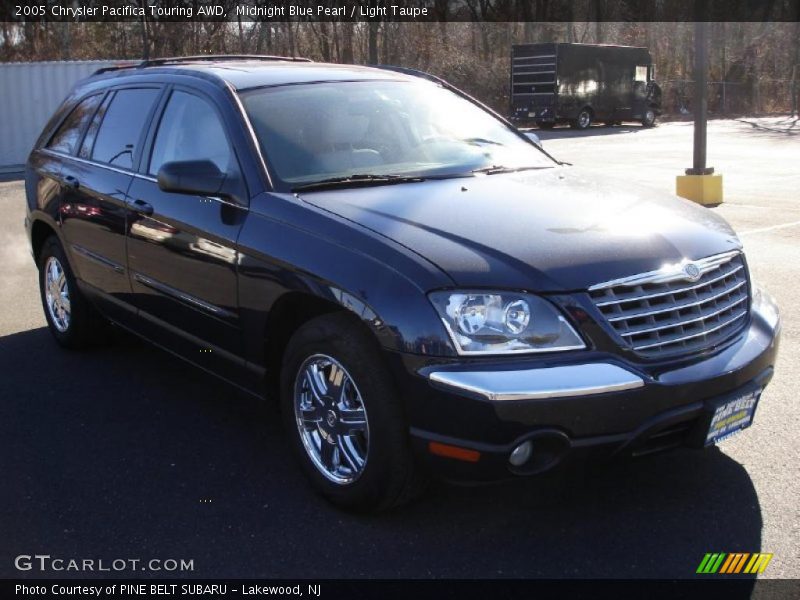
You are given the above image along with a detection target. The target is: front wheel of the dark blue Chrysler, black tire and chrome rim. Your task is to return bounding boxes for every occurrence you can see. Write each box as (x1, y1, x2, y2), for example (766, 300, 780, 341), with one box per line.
(281, 313, 422, 511)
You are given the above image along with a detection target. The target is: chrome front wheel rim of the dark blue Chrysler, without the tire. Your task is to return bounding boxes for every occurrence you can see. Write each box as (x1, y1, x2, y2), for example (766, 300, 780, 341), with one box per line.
(294, 354, 369, 485)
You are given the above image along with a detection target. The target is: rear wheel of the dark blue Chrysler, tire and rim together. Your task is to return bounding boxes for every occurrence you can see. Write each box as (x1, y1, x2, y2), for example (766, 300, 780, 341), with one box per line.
(38, 235, 109, 350)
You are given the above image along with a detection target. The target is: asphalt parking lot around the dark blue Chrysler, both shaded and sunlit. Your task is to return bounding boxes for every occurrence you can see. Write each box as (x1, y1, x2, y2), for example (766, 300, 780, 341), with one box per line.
(0, 117, 800, 578)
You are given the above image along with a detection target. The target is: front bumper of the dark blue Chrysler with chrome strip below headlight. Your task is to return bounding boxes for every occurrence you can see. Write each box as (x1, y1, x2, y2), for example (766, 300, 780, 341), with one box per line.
(394, 291, 780, 481)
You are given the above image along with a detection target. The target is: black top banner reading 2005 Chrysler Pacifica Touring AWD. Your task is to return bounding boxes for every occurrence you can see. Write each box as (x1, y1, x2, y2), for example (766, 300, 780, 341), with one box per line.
(0, 0, 800, 22)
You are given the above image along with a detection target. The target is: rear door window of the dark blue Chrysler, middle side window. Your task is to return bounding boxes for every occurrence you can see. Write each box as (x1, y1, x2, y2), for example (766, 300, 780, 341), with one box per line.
(91, 88, 159, 169)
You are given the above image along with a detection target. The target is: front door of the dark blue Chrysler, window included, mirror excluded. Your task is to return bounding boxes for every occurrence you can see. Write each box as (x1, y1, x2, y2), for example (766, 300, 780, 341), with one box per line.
(128, 86, 247, 378)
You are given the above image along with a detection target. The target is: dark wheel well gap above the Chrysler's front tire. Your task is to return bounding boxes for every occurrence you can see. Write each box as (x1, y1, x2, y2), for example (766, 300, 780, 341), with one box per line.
(264, 292, 355, 392)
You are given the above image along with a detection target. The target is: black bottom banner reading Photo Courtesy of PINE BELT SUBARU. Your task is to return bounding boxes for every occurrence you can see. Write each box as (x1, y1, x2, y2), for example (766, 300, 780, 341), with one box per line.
(0, 578, 800, 600)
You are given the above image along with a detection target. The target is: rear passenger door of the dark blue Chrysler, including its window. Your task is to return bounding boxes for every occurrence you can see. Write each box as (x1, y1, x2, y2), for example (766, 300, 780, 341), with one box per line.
(53, 87, 160, 320)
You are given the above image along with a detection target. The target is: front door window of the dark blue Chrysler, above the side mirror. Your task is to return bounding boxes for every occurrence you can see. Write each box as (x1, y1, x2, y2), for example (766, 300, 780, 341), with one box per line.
(148, 90, 235, 176)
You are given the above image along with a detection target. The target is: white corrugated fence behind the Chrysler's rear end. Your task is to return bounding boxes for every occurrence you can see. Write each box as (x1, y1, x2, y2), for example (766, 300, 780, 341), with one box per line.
(0, 61, 113, 172)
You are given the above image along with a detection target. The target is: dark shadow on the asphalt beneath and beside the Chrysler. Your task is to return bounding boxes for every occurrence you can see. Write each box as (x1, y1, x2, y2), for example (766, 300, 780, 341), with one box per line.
(0, 328, 762, 579)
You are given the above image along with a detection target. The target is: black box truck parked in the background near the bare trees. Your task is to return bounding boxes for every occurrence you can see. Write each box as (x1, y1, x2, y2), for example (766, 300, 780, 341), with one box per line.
(511, 43, 661, 129)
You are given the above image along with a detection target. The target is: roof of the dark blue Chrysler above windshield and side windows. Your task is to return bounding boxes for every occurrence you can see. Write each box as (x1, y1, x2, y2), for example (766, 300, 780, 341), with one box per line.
(90, 56, 417, 90)
